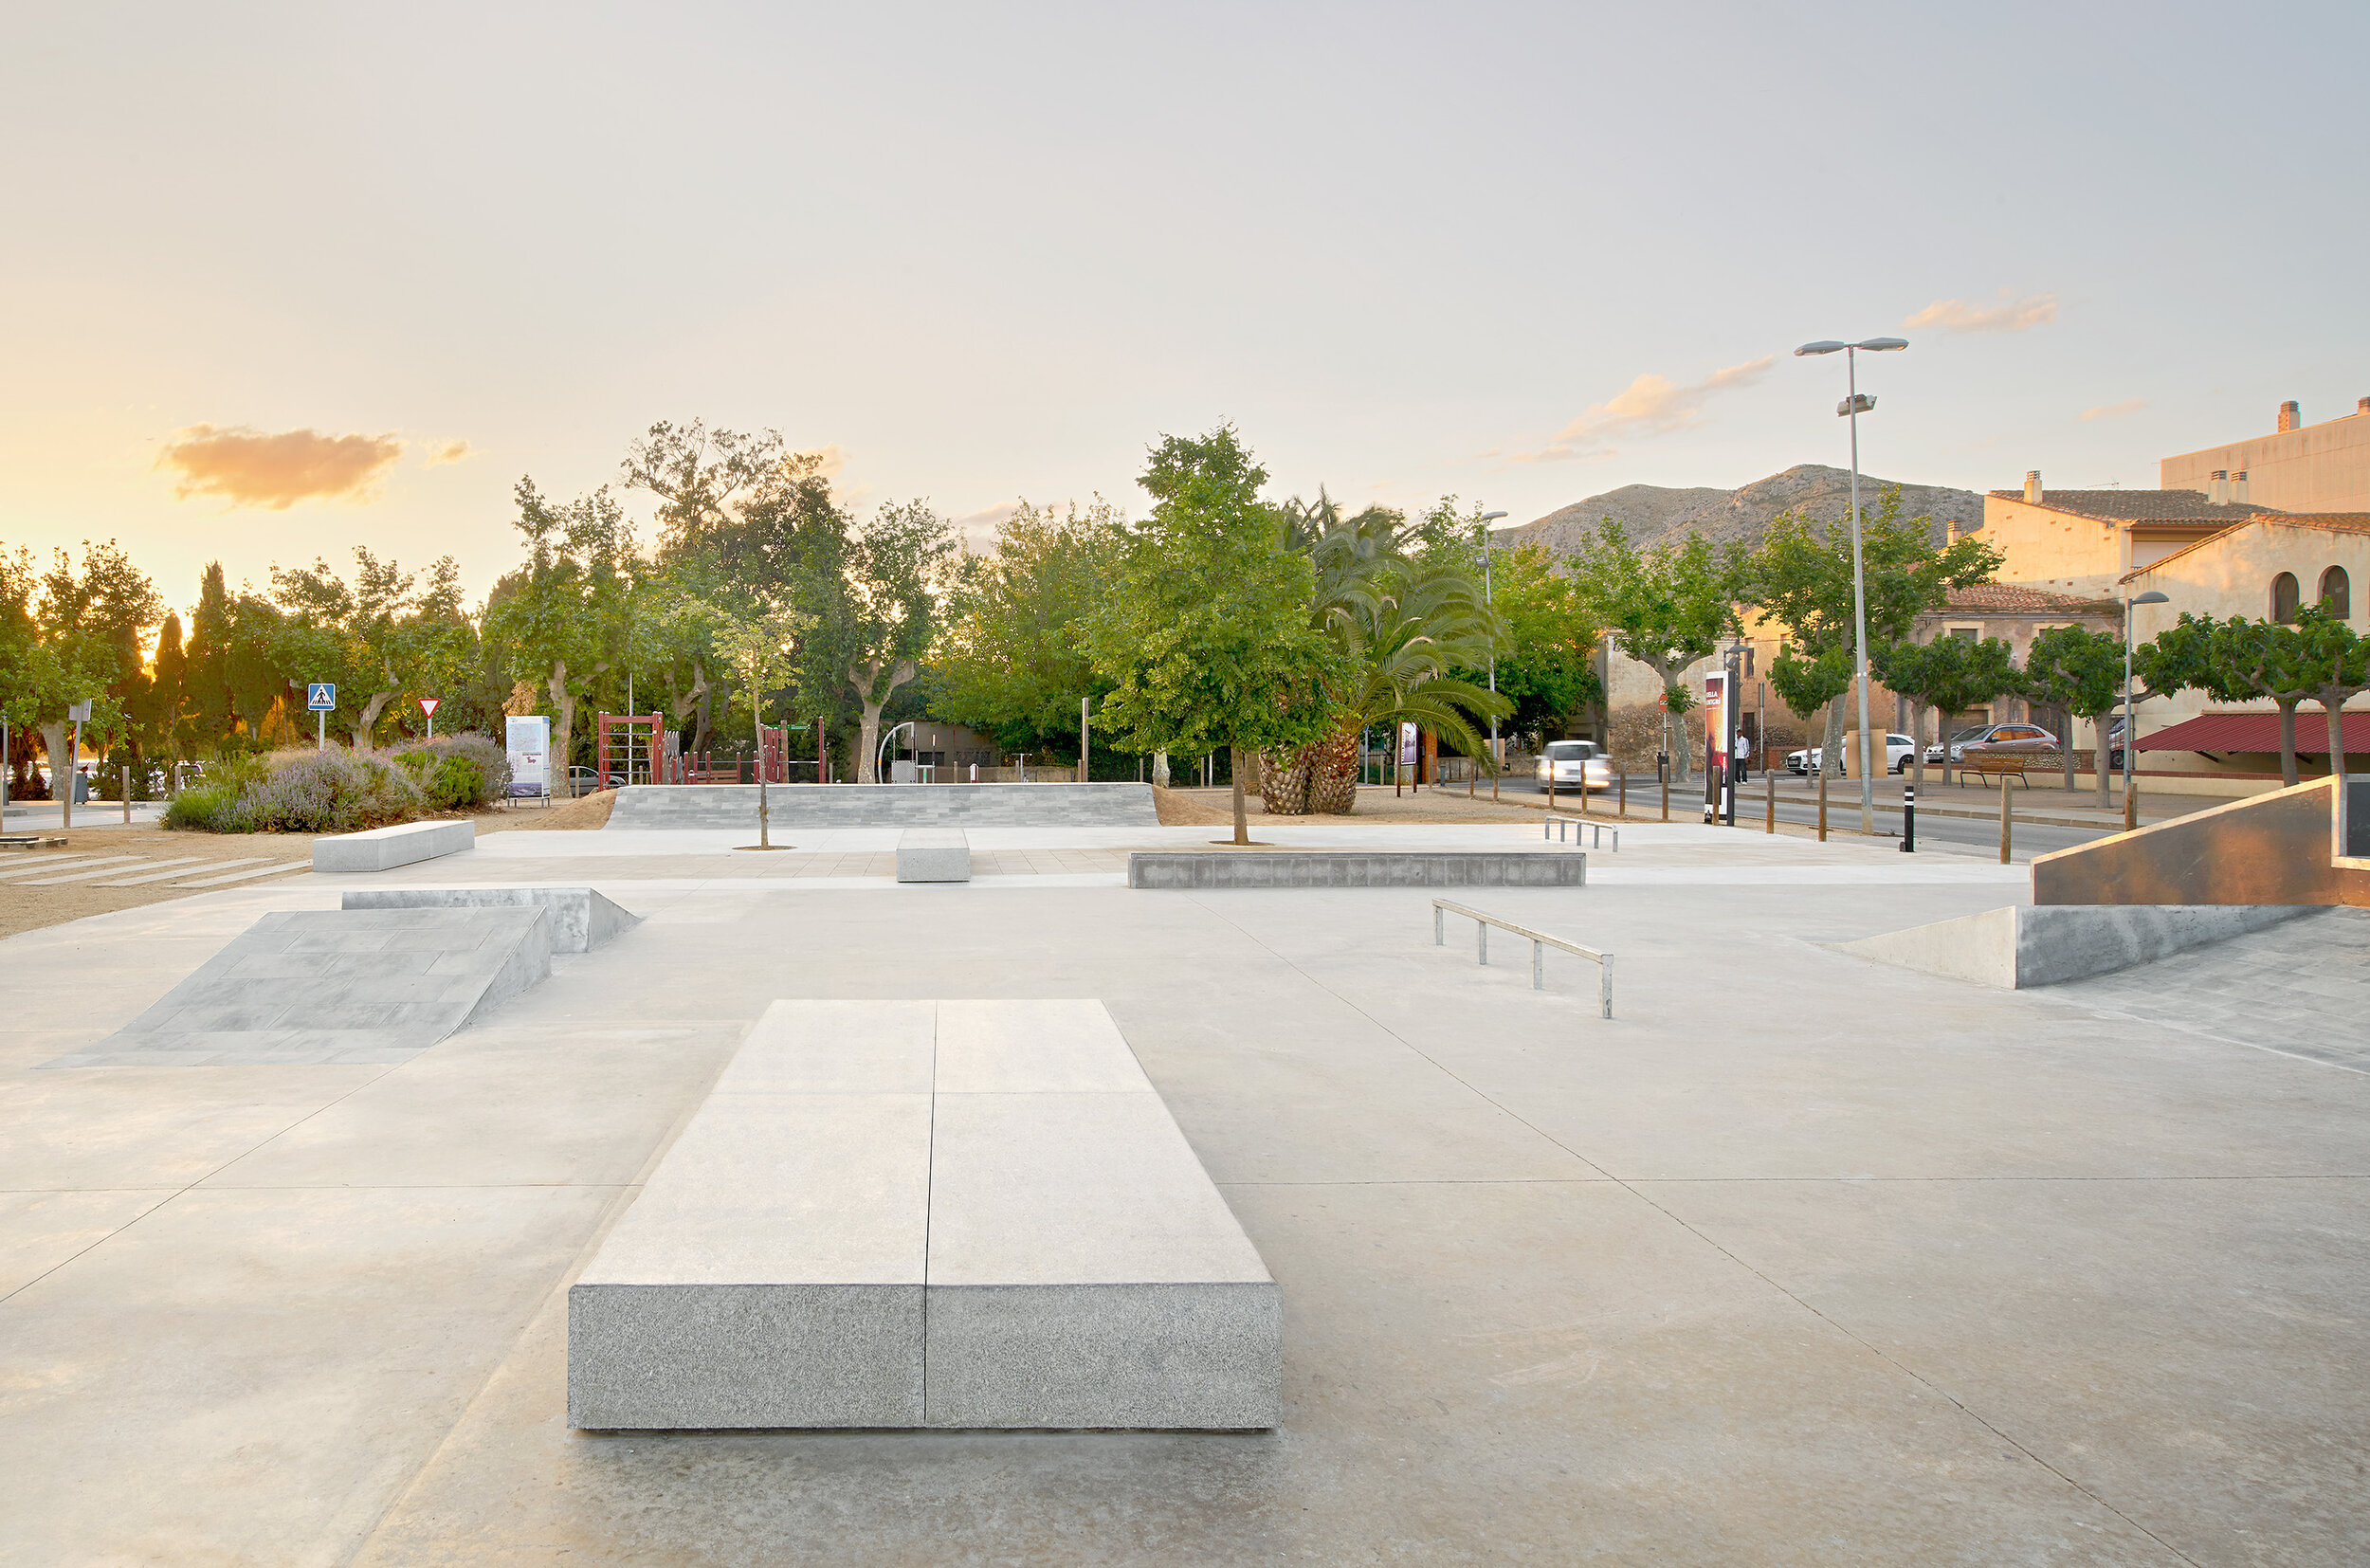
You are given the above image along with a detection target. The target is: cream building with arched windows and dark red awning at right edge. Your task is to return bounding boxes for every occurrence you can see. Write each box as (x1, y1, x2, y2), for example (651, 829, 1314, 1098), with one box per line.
(2119, 512, 2370, 773)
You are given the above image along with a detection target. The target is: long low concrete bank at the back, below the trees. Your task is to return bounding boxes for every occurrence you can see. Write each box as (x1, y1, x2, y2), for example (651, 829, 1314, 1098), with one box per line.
(610, 784, 1161, 833)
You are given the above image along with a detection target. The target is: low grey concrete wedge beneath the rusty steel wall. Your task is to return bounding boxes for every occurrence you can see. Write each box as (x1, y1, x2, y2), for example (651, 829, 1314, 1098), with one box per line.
(1834, 904, 2316, 990)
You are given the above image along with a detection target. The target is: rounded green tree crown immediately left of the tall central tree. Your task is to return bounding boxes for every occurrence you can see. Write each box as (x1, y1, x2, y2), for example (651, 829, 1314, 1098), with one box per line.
(929, 495, 1126, 751)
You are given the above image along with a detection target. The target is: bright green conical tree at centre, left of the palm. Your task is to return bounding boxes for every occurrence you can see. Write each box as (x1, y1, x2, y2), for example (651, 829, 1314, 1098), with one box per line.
(1088, 427, 1340, 843)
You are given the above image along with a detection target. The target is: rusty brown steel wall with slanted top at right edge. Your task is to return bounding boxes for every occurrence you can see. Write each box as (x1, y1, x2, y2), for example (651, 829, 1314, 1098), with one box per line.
(2033, 779, 2370, 904)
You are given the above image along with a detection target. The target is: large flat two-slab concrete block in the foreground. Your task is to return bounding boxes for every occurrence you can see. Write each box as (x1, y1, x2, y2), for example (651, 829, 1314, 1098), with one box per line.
(569, 1002, 1283, 1431)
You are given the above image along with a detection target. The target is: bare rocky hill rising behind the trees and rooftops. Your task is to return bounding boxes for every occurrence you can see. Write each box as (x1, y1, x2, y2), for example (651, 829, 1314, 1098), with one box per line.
(1498, 462, 1984, 555)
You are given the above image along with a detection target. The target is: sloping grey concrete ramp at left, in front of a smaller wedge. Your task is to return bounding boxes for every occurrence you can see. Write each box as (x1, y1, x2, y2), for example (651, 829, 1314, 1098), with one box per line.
(47, 907, 553, 1068)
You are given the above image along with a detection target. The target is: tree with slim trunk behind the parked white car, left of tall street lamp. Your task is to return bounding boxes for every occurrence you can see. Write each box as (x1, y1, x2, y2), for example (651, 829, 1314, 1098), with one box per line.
(1572, 517, 1744, 784)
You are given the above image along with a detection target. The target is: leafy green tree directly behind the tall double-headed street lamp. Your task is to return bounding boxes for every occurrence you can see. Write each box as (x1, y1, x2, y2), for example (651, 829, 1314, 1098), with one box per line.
(1742, 485, 2000, 786)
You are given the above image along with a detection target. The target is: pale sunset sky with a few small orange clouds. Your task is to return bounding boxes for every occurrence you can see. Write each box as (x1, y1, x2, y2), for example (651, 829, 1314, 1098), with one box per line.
(0, 0, 2370, 607)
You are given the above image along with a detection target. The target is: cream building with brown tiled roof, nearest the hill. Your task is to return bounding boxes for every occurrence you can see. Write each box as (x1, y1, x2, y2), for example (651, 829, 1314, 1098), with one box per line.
(1984, 469, 2269, 599)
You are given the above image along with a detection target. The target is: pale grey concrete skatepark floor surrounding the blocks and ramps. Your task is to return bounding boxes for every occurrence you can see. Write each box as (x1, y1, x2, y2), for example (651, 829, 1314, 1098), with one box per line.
(0, 824, 2370, 1566)
